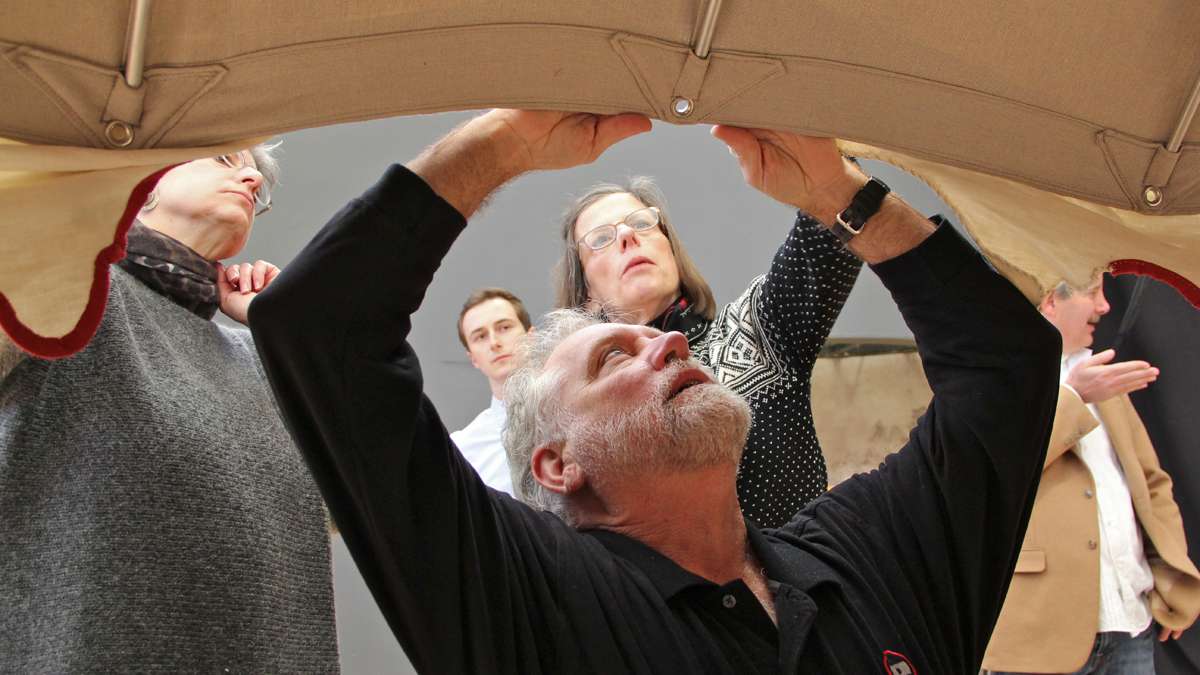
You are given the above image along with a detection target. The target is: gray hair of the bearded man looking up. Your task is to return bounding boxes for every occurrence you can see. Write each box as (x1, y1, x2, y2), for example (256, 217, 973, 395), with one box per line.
(503, 309, 601, 522)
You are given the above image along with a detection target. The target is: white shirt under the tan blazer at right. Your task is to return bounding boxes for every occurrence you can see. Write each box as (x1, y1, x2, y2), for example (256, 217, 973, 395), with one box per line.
(1060, 350, 1154, 635)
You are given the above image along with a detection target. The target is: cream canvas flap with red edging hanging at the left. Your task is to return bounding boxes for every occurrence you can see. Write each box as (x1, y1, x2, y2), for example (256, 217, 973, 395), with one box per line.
(0, 139, 260, 357)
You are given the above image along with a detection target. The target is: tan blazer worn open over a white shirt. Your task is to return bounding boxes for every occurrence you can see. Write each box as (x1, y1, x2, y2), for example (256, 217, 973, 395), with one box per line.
(983, 387, 1200, 673)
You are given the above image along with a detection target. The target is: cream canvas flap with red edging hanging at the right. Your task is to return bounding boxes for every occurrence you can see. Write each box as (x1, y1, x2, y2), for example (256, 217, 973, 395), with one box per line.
(841, 143, 1200, 305)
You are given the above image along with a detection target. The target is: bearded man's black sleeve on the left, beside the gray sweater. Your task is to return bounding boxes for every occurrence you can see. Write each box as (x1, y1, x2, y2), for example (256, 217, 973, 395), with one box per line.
(250, 166, 565, 673)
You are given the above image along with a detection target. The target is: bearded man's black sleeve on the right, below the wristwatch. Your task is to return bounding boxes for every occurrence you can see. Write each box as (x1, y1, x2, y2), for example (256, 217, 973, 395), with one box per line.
(796, 223, 1062, 673)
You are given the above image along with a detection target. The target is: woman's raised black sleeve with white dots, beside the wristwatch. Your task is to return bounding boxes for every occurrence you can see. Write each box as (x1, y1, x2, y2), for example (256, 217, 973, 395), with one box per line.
(757, 211, 863, 372)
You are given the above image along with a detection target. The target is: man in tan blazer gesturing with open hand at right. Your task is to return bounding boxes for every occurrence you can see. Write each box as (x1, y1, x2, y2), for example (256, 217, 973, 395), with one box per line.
(984, 280, 1200, 675)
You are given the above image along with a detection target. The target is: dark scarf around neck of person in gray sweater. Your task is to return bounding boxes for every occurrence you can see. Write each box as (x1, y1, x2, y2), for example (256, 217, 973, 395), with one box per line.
(116, 221, 221, 318)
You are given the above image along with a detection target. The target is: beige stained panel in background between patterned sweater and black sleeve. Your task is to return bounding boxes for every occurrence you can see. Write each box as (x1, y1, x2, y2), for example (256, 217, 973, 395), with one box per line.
(812, 340, 934, 486)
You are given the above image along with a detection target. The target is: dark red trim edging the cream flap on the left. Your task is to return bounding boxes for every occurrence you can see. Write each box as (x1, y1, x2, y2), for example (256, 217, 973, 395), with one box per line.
(0, 166, 174, 359)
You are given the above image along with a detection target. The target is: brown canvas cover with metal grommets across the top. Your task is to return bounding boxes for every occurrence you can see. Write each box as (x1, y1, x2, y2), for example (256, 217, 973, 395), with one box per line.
(0, 0, 1200, 357)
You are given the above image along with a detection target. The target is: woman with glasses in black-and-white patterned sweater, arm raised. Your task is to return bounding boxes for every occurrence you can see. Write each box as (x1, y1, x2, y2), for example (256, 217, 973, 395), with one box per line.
(557, 177, 862, 527)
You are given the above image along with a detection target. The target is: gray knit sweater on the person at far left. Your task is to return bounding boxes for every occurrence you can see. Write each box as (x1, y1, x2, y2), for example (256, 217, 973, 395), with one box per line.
(0, 267, 337, 673)
